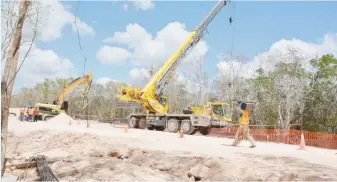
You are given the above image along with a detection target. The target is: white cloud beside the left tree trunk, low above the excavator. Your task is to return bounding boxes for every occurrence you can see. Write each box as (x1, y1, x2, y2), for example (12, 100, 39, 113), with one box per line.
(12, 45, 77, 87)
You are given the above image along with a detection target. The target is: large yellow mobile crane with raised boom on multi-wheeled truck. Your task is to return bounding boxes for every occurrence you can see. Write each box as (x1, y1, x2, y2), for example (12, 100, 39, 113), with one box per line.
(117, 0, 231, 135)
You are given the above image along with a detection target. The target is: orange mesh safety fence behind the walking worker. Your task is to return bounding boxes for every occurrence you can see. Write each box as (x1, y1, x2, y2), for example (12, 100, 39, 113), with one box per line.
(210, 128, 337, 149)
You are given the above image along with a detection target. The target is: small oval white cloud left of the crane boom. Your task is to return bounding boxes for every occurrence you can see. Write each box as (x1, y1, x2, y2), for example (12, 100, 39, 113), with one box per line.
(96, 45, 130, 64)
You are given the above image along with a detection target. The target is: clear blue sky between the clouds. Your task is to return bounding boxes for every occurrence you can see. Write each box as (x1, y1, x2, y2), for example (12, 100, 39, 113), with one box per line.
(12, 1, 337, 89)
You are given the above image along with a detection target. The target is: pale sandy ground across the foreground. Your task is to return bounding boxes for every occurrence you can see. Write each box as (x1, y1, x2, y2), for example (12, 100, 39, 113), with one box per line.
(6, 109, 337, 181)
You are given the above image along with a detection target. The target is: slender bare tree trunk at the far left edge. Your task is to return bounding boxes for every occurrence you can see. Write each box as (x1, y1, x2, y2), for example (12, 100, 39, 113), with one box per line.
(1, 1, 30, 176)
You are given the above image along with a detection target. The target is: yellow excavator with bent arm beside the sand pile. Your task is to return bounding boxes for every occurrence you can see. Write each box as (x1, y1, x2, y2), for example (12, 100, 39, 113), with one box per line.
(35, 72, 93, 120)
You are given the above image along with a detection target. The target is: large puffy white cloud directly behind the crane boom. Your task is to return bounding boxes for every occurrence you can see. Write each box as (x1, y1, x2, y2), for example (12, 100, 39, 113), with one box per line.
(103, 22, 208, 66)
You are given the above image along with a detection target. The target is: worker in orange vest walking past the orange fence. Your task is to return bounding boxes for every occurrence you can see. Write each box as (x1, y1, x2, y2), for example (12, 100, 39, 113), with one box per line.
(233, 102, 256, 148)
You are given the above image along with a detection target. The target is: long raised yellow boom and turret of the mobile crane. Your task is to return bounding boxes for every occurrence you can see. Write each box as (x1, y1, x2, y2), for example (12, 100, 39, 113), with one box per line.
(120, 0, 226, 114)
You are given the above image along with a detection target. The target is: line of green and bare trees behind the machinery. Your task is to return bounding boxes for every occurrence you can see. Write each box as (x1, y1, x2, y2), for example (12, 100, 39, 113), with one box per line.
(11, 54, 337, 133)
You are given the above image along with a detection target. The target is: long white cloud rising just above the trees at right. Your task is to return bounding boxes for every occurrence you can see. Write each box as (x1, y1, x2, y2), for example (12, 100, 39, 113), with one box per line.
(217, 33, 337, 77)
